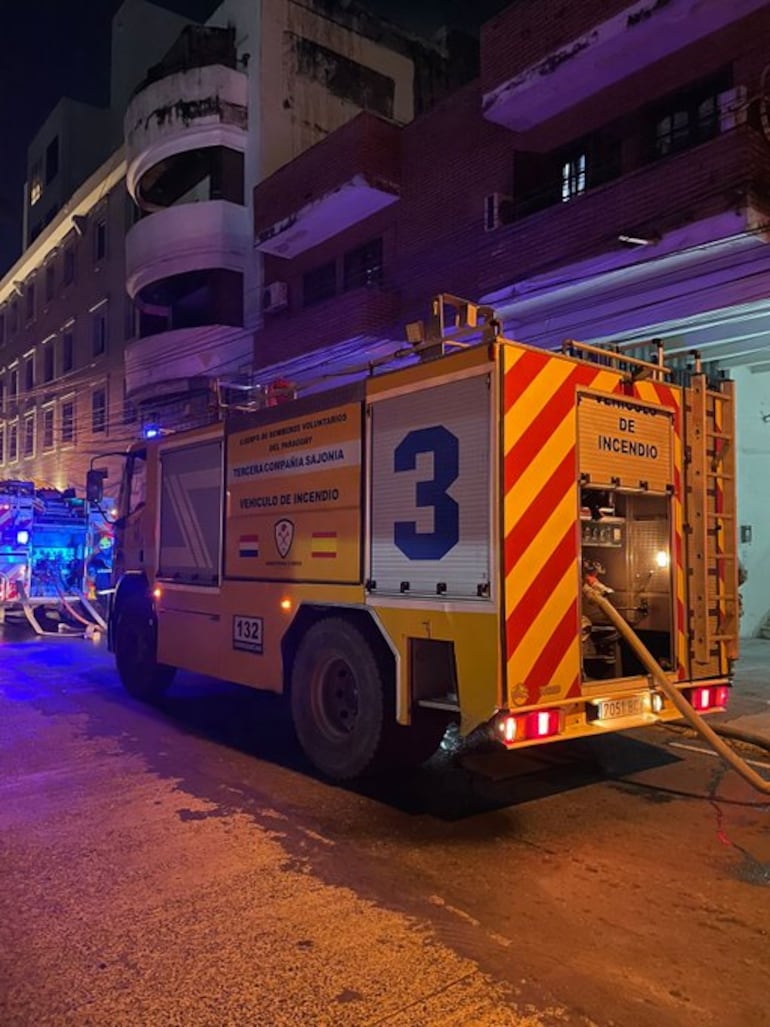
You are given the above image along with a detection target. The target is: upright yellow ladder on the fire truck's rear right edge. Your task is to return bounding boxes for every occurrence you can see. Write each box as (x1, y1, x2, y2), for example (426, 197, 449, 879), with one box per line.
(685, 369, 740, 673)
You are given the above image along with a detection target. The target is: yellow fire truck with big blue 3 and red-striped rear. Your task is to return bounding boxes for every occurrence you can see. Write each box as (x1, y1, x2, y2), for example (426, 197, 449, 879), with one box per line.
(99, 296, 738, 779)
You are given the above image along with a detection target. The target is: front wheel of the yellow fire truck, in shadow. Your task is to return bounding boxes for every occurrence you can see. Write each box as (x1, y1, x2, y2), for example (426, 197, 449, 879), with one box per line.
(115, 598, 176, 701)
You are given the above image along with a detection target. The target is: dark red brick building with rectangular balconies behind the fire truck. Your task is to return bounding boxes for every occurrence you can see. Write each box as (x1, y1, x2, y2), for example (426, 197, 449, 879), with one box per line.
(254, 0, 770, 634)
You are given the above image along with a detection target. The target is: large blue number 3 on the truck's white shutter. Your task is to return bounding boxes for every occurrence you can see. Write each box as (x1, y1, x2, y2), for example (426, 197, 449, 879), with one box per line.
(393, 425, 460, 560)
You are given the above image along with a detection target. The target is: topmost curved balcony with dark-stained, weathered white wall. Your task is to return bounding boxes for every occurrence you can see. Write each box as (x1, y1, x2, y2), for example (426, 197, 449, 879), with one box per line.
(124, 65, 247, 202)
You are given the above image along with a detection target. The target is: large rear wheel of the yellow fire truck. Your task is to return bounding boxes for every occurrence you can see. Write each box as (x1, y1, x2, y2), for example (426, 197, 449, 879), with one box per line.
(292, 617, 392, 781)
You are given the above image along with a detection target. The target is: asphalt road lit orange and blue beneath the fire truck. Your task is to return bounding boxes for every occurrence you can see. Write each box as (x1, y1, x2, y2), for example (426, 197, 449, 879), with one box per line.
(0, 629, 770, 1027)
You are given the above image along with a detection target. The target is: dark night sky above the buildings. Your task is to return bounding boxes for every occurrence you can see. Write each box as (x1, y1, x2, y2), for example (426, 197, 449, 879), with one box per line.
(0, 0, 510, 275)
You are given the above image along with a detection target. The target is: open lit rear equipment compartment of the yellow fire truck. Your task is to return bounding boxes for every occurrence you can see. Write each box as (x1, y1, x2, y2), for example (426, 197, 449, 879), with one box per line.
(580, 488, 673, 680)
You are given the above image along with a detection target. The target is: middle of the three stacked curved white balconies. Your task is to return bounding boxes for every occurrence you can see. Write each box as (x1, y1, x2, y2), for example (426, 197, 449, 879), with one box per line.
(125, 200, 252, 299)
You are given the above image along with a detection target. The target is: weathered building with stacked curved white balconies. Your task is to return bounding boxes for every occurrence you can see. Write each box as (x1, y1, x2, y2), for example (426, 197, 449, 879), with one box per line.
(125, 0, 475, 429)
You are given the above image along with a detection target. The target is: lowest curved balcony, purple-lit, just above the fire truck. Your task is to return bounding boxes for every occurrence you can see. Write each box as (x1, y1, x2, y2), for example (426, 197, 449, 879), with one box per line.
(125, 325, 254, 403)
